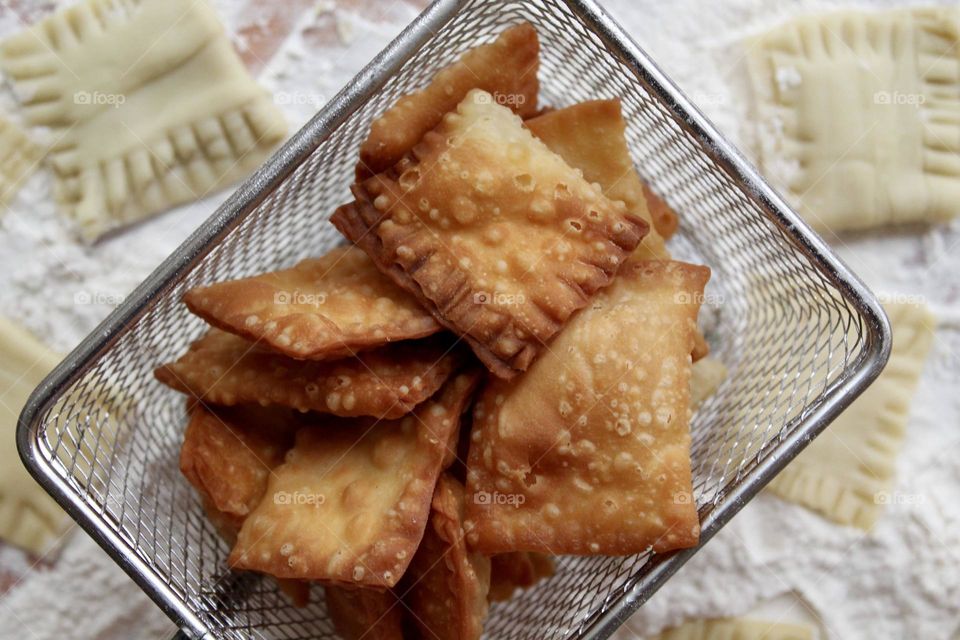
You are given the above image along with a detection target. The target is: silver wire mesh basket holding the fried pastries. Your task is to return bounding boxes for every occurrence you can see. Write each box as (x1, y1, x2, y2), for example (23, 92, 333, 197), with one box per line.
(18, 0, 890, 640)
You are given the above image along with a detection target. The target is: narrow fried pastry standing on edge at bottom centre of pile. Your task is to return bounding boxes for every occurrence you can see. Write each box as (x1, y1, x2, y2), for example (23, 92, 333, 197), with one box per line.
(404, 474, 490, 640)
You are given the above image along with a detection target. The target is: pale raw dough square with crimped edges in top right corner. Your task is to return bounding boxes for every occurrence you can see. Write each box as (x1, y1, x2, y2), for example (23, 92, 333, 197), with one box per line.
(749, 7, 960, 231)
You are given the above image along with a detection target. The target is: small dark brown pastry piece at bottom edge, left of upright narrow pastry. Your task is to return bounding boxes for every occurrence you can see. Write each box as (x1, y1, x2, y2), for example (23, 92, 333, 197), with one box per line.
(324, 585, 403, 640)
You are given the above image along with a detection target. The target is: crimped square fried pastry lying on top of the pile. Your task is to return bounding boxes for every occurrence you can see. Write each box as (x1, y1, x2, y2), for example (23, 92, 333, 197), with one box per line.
(333, 90, 649, 378)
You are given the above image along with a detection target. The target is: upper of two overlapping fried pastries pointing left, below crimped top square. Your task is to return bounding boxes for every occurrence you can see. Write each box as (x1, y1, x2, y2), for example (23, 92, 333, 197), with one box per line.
(183, 247, 440, 360)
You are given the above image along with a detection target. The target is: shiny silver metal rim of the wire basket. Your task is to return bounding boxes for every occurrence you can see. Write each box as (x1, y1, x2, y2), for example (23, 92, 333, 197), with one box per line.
(16, 0, 892, 640)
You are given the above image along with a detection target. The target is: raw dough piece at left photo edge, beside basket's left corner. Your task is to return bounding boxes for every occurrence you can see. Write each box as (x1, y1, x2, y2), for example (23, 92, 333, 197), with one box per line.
(0, 316, 72, 556)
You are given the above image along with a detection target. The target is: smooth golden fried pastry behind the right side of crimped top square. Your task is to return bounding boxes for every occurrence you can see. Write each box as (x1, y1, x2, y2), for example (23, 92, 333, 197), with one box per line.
(526, 100, 670, 260)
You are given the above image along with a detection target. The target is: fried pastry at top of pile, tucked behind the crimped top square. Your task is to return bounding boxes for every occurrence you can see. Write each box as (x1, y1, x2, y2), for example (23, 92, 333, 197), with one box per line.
(357, 23, 540, 178)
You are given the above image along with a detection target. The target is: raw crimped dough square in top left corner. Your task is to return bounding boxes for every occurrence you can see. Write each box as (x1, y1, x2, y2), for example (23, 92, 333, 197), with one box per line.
(0, 0, 286, 240)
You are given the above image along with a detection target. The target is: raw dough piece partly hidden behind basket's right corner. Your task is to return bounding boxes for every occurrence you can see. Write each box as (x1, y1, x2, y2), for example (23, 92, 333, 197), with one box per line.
(768, 303, 935, 530)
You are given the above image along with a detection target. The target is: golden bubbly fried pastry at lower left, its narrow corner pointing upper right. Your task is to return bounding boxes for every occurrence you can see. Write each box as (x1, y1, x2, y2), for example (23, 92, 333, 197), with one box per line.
(230, 373, 479, 588)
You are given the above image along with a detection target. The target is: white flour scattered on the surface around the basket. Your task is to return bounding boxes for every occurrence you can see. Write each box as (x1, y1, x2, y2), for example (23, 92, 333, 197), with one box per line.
(0, 0, 960, 640)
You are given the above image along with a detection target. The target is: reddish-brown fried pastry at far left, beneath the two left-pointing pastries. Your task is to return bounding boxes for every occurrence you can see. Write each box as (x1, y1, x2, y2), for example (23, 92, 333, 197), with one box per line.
(180, 403, 293, 517)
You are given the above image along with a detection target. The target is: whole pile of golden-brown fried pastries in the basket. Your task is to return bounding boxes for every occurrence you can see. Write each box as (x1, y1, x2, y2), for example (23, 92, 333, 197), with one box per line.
(156, 24, 710, 640)
